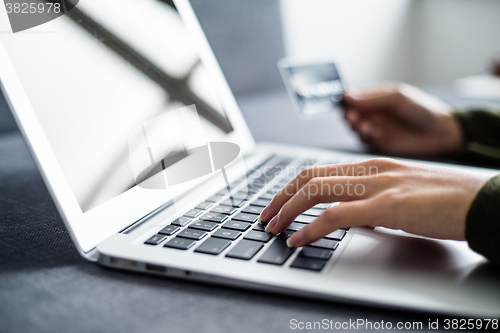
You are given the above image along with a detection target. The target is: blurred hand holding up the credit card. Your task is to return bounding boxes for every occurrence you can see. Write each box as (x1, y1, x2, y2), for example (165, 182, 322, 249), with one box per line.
(344, 84, 464, 156)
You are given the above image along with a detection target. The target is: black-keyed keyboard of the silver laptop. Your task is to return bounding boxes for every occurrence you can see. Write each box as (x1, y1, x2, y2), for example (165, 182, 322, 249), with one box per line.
(145, 156, 348, 272)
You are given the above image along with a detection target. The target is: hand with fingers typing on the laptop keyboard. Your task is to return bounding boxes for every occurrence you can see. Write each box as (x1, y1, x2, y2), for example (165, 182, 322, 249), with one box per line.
(259, 159, 489, 247)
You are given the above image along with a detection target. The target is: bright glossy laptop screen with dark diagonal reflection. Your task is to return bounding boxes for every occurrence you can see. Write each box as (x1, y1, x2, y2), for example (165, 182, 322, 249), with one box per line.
(0, 0, 233, 212)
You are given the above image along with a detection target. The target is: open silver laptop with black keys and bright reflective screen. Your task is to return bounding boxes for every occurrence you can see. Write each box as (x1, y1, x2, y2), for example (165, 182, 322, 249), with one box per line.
(0, 0, 500, 318)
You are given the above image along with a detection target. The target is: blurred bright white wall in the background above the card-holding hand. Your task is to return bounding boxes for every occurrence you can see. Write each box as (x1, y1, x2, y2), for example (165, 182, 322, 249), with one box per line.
(281, 0, 500, 85)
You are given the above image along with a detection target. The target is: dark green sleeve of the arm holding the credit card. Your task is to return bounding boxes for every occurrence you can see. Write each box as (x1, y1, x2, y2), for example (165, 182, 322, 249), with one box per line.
(455, 110, 500, 166)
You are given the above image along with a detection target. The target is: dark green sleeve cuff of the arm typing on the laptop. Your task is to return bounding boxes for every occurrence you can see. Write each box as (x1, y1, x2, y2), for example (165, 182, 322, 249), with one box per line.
(465, 175, 500, 265)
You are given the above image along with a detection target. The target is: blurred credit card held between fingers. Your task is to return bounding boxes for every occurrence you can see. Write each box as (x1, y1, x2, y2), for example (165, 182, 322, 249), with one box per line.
(278, 59, 344, 118)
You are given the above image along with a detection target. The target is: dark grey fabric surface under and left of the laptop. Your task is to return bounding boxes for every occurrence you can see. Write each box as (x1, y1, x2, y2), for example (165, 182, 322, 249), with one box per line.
(0, 89, 496, 333)
